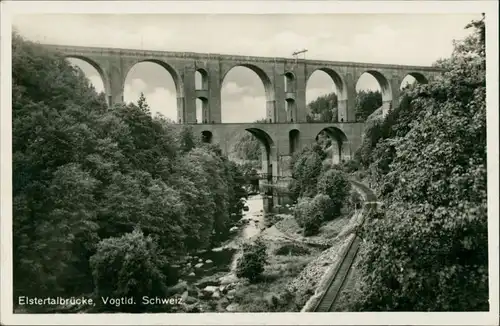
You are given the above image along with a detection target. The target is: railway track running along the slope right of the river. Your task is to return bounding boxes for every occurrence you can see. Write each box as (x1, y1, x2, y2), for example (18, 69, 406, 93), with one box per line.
(313, 180, 378, 312)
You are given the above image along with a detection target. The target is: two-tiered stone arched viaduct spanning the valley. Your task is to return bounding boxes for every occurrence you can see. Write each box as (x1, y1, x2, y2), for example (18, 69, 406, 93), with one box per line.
(44, 44, 440, 191)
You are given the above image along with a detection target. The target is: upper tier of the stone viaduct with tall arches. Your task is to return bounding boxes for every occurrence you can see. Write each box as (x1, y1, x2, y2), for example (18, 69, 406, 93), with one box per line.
(45, 45, 440, 123)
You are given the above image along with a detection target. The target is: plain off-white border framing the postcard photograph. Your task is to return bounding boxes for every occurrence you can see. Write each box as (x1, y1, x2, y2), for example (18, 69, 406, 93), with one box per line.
(0, 1, 499, 325)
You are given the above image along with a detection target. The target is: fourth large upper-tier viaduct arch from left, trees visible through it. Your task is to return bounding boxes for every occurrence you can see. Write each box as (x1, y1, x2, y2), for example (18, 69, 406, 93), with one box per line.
(306, 67, 348, 122)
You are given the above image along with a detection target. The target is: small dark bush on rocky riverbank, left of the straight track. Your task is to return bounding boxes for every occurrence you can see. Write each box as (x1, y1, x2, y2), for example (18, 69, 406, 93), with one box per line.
(236, 240, 267, 283)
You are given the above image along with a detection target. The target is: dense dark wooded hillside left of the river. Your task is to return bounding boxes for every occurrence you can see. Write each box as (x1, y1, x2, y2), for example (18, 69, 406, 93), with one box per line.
(12, 35, 245, 308)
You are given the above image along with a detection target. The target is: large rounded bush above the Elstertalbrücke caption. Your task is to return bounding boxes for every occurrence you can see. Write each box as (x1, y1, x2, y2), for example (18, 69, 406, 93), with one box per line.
(90, 229, 172, 312)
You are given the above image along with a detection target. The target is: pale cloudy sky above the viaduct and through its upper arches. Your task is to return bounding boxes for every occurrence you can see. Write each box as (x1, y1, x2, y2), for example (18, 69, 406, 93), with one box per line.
(14, 14, 479, 122)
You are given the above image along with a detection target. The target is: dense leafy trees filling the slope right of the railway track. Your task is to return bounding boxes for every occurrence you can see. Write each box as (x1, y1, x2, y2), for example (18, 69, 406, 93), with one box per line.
(350, 15, 488, 311)
